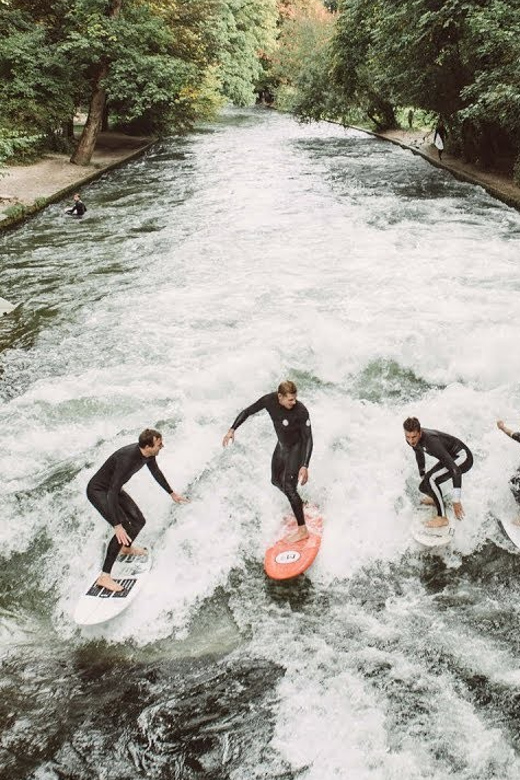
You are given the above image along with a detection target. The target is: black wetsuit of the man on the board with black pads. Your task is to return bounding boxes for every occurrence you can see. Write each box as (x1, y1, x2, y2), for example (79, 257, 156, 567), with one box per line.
(87, 444, 173, 574)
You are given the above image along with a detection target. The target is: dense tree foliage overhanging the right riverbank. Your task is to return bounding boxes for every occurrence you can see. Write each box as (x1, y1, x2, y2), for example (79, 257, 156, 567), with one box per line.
(274, 0, 520, 169)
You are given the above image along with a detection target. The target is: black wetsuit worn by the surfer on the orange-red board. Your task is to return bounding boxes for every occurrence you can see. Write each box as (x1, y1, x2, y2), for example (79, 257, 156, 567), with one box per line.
(231, 393, 312, 525)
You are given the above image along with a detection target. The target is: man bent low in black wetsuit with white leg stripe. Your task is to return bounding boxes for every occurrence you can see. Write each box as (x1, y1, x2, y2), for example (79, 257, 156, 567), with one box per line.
(403, 417, 473, 528)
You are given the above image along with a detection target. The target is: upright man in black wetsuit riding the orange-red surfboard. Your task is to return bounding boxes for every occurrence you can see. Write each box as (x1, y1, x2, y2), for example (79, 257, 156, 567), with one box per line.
(222, 380, 312, 542)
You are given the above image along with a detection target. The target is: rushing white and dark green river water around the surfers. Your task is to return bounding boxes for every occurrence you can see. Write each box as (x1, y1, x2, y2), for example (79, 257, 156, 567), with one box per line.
(0, 109, 520, 780)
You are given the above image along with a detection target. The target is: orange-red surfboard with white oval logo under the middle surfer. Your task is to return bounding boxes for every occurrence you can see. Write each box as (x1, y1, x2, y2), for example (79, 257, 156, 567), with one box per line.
(264, 506, 323, 580)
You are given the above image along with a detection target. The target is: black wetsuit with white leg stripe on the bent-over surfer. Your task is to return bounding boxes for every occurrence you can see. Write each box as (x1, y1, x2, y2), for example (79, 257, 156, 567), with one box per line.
(410, 428, 473, 517)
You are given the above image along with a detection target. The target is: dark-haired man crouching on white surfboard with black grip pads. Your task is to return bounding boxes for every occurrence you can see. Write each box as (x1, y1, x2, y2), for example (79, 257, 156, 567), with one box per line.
(87, 428, 188, 592)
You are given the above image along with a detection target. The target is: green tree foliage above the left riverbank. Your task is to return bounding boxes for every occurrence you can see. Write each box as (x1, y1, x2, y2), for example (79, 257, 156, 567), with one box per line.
(0, 0, 277, 148)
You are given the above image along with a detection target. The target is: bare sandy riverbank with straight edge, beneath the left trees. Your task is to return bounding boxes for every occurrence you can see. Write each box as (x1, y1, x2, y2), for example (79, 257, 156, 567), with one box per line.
(0, 132, 155, 230)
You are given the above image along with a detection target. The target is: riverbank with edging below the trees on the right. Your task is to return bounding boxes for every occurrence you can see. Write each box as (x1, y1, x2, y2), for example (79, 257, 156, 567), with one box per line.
(362, 127, 520, 210)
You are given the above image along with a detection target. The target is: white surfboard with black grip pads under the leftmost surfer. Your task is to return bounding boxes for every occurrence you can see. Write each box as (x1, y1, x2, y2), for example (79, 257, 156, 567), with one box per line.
(74, 550, 152, 626)
